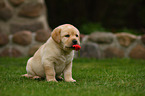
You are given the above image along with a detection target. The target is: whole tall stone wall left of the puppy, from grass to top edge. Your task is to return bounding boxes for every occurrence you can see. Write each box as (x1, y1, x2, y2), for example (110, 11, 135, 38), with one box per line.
(0, 0, 50, 57)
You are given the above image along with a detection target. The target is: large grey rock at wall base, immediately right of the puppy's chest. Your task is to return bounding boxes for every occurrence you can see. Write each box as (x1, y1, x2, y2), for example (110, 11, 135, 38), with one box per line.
(80, 42, 101, 59)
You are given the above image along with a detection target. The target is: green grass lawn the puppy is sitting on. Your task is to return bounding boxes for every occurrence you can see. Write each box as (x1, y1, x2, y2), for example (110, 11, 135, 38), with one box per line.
(0, 58, 145, 96)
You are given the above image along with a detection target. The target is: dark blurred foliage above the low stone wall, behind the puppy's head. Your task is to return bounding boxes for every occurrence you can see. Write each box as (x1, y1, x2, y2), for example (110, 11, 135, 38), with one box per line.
(45, 0, 145, 35)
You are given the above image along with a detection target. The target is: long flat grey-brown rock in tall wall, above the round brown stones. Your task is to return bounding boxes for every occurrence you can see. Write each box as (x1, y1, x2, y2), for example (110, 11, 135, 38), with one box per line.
(10, 22, 44, 34)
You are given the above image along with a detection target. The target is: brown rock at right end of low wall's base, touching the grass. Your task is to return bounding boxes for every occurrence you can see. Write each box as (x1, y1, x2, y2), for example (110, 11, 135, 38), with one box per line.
(129, 44, 145, 59)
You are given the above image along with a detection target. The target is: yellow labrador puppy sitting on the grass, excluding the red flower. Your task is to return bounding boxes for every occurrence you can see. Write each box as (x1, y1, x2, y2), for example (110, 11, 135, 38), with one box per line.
(23, 24, 80, 82)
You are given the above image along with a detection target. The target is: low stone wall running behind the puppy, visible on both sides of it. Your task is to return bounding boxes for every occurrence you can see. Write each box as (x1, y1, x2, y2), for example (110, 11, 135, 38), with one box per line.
(0, 29, 145, 59)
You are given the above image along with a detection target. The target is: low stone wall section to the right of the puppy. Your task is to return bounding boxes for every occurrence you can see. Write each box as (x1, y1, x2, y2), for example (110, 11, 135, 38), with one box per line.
(76, 32, 145, 59)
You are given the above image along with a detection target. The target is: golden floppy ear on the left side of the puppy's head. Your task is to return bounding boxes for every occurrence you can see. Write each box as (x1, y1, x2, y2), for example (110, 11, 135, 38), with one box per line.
(51, 27, 61, 43)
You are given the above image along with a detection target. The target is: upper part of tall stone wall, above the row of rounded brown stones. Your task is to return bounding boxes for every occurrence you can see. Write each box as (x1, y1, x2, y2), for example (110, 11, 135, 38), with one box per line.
(0, 0, 49, 34)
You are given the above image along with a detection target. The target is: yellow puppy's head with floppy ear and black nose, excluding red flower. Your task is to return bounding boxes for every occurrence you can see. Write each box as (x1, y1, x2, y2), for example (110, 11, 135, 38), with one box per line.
(51, 24, 80, 50)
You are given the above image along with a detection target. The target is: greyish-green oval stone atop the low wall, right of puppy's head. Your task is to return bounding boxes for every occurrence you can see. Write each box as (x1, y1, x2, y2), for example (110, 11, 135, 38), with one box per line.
(88, 32, 114, 44)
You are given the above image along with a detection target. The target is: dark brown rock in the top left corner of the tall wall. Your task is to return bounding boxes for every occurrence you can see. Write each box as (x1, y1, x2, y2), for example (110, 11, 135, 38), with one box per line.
(0, 0, 13, 21)
